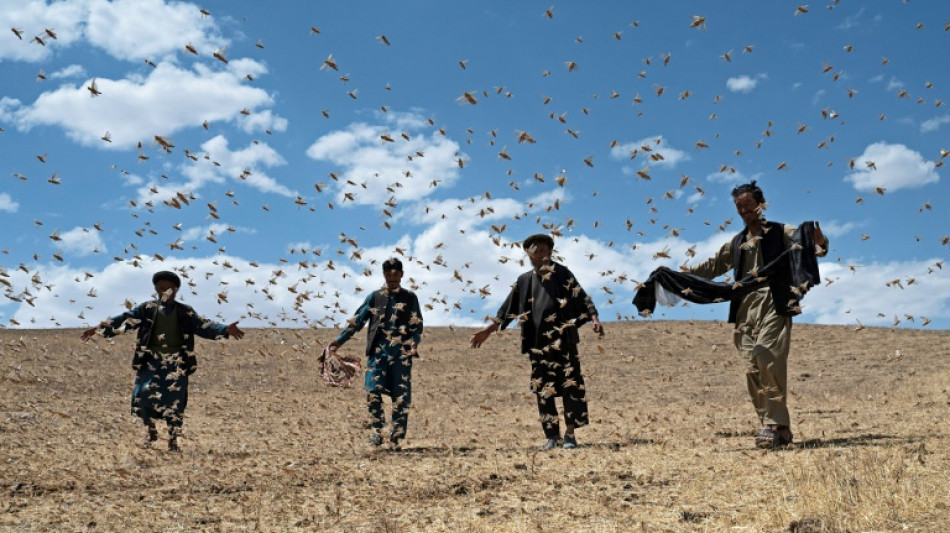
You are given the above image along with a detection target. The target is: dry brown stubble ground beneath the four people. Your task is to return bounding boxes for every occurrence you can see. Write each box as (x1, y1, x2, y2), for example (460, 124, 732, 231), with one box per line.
(0, 321, 950, 532)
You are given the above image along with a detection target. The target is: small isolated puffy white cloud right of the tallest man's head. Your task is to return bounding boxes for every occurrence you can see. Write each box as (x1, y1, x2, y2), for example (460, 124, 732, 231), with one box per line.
(844, 142, 940, 192)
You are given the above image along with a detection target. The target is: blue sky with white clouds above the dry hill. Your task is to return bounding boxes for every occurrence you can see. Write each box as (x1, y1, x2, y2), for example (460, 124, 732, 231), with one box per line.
(0, 0, 950, 329)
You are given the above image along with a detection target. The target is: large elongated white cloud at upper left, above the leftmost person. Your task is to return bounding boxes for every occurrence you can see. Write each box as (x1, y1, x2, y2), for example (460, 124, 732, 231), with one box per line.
(14, 63, 273, 149)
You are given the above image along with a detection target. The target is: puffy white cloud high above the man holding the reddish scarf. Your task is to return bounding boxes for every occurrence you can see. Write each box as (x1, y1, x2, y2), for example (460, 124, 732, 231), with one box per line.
(307, 114, 464, 205)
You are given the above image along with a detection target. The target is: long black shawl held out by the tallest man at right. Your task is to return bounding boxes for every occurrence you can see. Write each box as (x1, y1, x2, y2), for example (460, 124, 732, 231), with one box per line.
(633, 221, 821, 322)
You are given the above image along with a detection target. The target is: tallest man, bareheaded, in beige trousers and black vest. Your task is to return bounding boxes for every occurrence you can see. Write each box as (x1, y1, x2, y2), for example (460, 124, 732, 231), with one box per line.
(686, 181, 828, 448)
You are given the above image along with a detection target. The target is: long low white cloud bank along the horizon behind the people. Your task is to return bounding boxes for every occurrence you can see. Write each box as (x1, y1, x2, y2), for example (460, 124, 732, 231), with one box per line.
(0, 206, 950, 327)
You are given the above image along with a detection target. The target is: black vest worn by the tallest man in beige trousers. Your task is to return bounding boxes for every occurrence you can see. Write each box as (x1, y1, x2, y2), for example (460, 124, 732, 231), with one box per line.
(729, 222, 801, 324)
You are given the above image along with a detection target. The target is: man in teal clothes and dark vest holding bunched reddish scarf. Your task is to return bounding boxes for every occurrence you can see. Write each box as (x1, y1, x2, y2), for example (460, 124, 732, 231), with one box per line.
(329, 258, 422, 449)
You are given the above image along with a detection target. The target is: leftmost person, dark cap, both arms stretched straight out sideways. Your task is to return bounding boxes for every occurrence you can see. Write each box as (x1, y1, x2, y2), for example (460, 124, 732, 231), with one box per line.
(82, 271, 244, 451)
